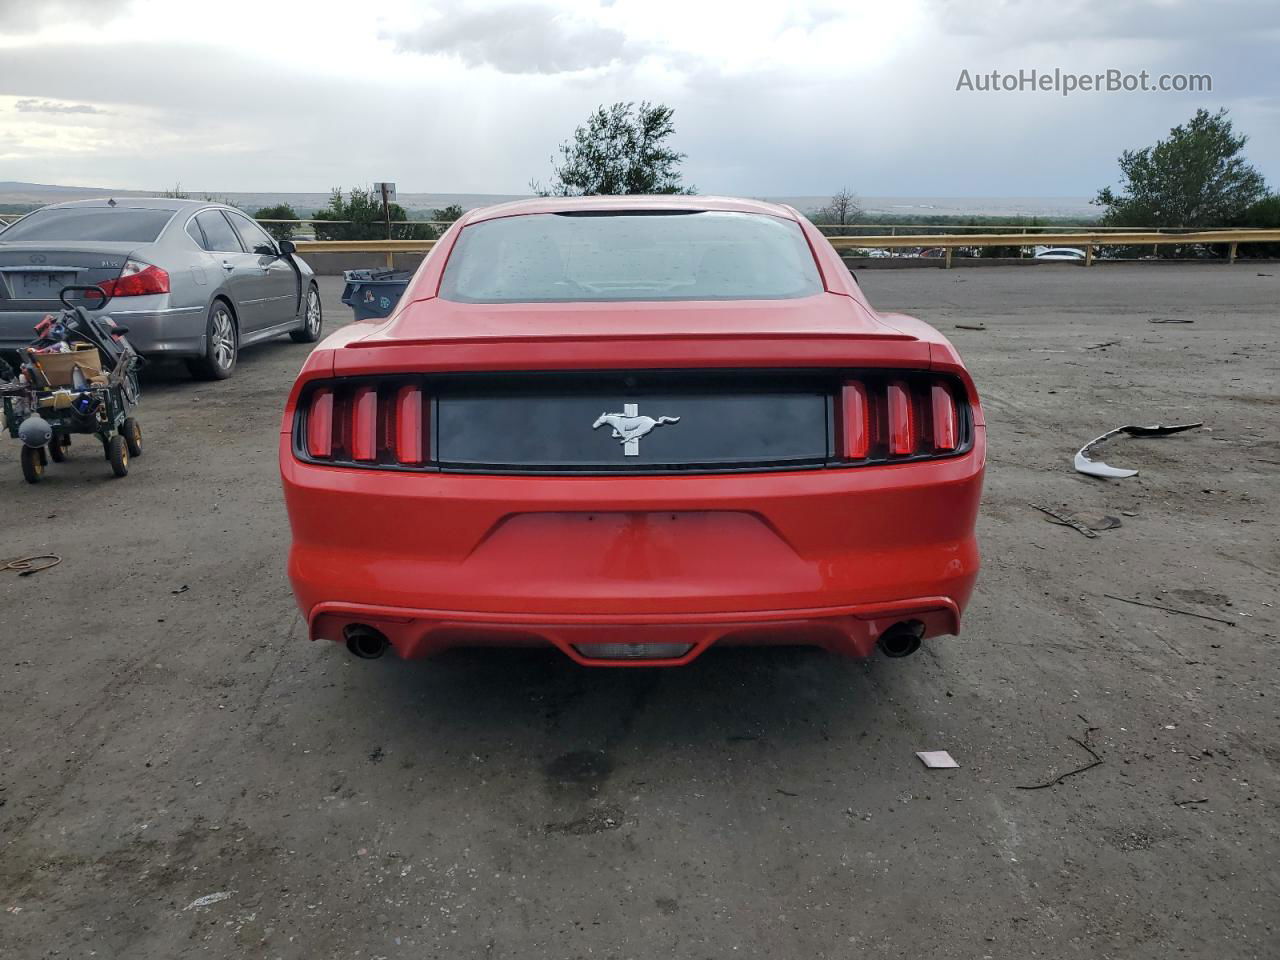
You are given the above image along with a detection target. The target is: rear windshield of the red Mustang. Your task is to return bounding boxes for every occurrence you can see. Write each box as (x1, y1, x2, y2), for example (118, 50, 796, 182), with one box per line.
(440, 211, 822, 303)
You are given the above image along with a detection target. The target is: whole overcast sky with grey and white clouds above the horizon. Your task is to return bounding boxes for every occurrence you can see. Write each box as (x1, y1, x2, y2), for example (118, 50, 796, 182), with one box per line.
(0, 0, 1280, 197)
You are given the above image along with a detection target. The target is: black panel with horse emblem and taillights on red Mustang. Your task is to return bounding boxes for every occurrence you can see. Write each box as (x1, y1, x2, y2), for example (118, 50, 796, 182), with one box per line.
(293, 369, 973, 475)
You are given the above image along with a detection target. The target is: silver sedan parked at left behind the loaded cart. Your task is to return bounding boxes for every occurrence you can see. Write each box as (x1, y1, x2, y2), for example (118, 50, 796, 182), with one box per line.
(0, 197, 321, 380)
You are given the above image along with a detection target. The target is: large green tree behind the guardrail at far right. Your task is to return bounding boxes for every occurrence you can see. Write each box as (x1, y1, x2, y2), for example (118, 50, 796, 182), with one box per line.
(1093, 108, 1267, 227)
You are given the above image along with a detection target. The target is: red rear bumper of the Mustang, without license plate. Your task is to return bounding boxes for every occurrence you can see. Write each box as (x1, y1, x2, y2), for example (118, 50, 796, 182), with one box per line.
(280, 426, 984, 666)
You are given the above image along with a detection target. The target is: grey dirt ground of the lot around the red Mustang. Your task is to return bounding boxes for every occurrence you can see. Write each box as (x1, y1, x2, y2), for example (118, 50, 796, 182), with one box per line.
(0, 264, 1280, 960)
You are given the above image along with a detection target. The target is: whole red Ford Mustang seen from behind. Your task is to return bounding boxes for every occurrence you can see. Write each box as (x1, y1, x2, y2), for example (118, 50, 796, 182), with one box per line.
(280, 197, 986, 666)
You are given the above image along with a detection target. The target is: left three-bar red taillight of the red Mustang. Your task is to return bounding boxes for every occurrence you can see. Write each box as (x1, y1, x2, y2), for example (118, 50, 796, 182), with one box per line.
(297, 381, 430, 466)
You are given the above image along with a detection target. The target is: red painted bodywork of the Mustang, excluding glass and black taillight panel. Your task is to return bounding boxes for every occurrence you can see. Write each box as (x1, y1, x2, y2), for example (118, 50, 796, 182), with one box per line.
(279, 197, 986, 666)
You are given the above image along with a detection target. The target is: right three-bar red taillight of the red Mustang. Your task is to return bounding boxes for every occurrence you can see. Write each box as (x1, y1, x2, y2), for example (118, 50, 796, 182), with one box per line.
(836, 375, 968, 463)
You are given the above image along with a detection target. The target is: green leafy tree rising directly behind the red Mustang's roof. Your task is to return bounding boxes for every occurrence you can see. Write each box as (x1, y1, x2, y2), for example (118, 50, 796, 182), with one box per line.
(530, 101, 695, 197)
